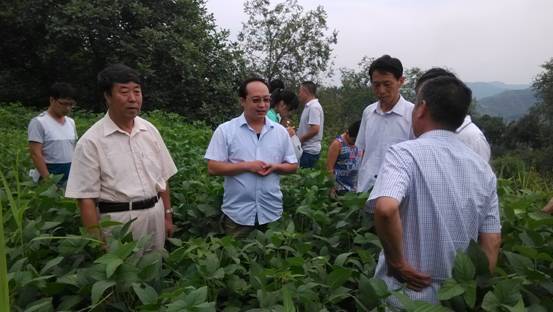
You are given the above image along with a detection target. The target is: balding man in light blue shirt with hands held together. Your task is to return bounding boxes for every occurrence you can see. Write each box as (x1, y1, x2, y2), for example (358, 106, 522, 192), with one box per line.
(205, 78, 298, 237)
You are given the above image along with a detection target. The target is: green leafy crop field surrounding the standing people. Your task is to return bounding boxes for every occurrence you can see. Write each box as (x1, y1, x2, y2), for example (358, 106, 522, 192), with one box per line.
(0, 105, 553, 311)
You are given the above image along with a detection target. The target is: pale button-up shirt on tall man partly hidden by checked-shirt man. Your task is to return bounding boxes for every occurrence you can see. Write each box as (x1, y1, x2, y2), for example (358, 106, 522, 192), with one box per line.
(355, 96, 414, 192)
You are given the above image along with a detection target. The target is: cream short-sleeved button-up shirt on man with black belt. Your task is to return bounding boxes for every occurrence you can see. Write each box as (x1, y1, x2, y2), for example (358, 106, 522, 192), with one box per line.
(65, 114, 177, 202)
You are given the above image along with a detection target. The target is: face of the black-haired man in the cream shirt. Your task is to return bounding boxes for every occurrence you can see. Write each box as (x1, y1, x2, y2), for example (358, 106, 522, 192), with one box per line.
(104, 82, 142, 122)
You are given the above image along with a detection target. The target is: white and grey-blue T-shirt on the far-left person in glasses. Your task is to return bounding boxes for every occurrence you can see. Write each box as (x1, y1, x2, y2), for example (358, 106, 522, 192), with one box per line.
(28, 112, 77, 164)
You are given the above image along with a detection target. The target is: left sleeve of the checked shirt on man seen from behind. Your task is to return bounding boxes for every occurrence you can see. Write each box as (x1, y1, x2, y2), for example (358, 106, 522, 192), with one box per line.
(366, 146, 411, 213)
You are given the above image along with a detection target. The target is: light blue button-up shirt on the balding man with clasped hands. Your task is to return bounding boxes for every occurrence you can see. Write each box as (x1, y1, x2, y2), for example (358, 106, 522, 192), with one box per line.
(204, 114, 298, 225)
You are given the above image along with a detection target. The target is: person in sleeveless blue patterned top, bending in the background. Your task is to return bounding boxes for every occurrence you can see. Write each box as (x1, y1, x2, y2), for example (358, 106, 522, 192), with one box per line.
(326, 120, 363, 197)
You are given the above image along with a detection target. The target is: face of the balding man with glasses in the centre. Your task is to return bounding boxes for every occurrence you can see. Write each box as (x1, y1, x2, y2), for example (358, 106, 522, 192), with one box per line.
(240, 81, 271, 121)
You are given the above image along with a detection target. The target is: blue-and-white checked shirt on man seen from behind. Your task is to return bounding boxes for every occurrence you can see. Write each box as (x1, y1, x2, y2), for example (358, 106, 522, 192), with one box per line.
(368, 130, 501, 304)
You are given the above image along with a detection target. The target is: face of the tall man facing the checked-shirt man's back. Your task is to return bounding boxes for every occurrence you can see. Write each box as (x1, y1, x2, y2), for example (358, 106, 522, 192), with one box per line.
(371, 70, 404, 110)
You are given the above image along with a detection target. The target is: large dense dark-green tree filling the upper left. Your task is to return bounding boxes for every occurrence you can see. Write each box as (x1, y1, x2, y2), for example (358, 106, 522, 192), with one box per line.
(0, 0, 243, 122)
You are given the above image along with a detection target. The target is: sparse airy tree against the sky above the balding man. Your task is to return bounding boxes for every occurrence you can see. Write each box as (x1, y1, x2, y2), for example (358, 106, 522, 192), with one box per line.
(238, 0, 337, 86)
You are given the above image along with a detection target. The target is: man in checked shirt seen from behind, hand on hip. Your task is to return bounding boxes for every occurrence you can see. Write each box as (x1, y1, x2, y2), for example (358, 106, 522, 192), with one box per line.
(368, 77, 501, 305)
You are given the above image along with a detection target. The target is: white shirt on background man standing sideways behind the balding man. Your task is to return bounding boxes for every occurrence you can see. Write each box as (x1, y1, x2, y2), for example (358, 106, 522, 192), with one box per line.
(298, 99, 324, 154)
